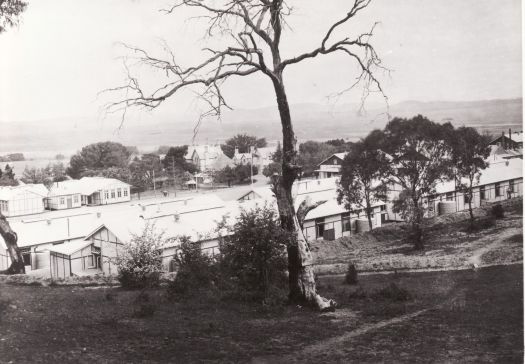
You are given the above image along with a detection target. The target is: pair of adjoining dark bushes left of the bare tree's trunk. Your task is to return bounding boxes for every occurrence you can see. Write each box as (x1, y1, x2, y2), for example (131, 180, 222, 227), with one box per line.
(169, 206, 290, 304)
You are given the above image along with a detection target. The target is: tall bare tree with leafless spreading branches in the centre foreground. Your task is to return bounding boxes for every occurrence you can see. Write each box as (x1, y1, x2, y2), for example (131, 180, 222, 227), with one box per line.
(105, 0, 386, 310)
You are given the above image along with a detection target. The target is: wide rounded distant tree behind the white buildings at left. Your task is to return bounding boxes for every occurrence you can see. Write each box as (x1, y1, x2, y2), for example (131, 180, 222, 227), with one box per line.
(66, 142, 130, 178)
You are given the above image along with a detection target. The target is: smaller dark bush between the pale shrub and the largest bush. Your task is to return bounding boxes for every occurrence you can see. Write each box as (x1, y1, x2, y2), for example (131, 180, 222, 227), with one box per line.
(168, 236, 218, 297)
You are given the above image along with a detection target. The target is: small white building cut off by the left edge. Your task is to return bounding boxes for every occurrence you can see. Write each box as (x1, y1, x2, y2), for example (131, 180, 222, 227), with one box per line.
(0, 184, 48, 217)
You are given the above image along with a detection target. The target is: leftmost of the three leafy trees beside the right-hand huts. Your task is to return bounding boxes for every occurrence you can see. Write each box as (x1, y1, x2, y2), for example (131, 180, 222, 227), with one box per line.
(337, 133, 390, 229)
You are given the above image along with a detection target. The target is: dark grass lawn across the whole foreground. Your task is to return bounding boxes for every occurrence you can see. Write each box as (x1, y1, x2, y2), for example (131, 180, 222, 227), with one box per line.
(0, 265, 523, 363)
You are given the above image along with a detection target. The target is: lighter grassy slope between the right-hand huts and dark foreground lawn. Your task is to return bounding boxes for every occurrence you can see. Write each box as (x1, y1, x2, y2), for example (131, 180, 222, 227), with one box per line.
(311, 198, 523, 274)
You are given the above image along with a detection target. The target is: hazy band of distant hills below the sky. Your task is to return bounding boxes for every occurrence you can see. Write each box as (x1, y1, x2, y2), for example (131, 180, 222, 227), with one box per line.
(0, 98, 523, 158)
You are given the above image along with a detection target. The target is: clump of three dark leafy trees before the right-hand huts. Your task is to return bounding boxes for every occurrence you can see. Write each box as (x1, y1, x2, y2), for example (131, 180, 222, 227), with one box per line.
(338, 115, 490, 249)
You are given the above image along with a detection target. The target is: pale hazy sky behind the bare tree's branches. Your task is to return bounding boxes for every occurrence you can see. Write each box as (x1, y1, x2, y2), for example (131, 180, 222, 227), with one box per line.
(0, 0, 522, 121)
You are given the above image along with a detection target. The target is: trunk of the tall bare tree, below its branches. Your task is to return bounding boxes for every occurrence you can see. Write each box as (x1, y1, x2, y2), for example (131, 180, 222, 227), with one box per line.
(273, 75, 335, 311)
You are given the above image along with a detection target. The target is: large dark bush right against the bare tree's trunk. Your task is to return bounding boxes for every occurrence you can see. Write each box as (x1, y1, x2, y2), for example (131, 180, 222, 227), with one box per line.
(218, 205, 291, 304)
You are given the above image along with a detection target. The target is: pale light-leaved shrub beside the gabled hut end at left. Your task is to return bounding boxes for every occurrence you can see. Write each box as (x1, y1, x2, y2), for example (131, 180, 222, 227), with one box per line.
(116, 225, 163, 289)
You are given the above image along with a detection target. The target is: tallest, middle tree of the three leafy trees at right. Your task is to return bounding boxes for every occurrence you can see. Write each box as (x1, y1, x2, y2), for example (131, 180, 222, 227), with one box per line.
(380, 115, 454, 249)
